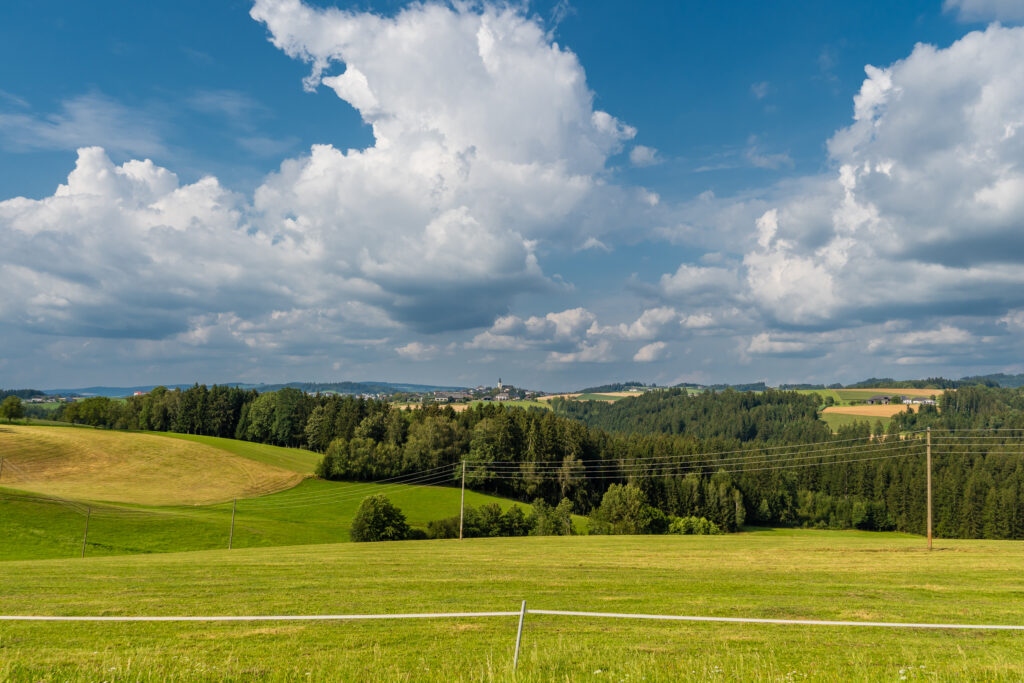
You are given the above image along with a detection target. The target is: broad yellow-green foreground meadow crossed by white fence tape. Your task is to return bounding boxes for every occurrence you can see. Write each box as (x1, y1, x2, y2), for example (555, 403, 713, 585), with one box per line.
(0, 531, 1024, 681)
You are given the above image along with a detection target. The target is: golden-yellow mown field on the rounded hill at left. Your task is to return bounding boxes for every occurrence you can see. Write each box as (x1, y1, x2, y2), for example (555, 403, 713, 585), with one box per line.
(0, 425, 304, 505)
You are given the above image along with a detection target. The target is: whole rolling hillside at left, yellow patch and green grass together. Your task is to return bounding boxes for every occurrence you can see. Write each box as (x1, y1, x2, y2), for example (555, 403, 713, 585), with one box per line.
(0, 426, 552, 560)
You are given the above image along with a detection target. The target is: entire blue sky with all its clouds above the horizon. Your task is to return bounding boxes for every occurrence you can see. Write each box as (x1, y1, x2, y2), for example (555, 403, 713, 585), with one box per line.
(0, 0, 1024, 390)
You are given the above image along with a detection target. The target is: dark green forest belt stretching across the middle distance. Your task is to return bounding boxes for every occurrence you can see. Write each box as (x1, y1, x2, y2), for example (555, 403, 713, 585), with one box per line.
(44, 385, 1024, 539)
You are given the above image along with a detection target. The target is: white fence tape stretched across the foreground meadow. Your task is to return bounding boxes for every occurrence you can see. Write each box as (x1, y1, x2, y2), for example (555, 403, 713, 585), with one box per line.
(0, 609, 1024, 631)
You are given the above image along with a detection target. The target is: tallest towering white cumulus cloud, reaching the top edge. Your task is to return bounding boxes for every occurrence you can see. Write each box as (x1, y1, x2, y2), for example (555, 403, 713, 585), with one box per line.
(245, 0, 640, 332)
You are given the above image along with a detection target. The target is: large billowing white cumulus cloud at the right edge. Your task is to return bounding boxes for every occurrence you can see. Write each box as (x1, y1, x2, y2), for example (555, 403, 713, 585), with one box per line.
(737, 26, 1024, 326)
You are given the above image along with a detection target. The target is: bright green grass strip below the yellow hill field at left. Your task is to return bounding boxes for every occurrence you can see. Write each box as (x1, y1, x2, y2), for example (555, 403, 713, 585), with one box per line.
(0, 479, 544, 560)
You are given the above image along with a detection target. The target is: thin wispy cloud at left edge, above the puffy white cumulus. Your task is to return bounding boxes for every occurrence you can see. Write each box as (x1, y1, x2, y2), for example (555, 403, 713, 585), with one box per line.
(0, 93, 166, 156)
